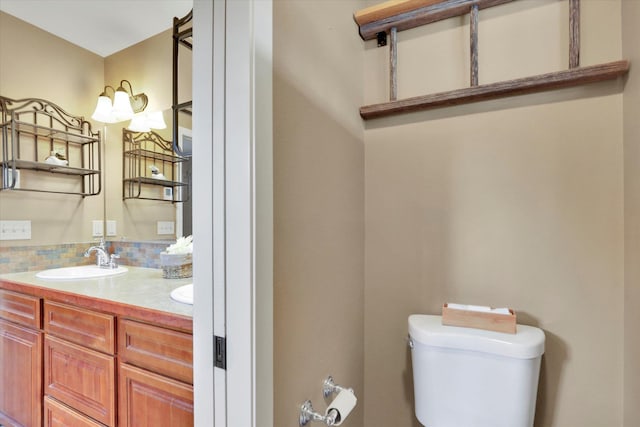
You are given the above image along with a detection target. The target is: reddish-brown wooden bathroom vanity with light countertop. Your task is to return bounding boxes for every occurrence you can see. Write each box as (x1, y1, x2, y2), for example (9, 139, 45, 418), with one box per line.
(0, 267, 193, 427)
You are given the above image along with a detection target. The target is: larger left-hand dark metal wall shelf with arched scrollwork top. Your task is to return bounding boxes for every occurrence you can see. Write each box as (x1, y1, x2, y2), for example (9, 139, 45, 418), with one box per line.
(0, 96, 101, 197)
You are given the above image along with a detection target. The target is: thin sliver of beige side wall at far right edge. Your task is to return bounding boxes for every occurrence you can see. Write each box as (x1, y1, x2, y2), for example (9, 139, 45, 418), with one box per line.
(622, 1, 640, 427)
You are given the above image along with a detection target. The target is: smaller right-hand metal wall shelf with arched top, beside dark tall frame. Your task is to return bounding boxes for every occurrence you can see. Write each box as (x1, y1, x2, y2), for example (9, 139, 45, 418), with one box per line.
(122, 129, 190, 202)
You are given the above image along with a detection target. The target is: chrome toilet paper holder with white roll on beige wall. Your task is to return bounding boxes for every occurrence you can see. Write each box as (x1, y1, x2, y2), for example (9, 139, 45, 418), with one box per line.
(299, 375, 358, 427)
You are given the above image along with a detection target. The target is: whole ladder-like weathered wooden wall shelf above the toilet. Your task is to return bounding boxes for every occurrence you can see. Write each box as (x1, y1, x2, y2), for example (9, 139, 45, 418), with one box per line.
(354, 0, 630, 120)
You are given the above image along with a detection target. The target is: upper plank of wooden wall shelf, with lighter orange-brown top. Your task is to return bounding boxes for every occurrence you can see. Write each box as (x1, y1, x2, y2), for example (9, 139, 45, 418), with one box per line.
(353, 0, 513, 40)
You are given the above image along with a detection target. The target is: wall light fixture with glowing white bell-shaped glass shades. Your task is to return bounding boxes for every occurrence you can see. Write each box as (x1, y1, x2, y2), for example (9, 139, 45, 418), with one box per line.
(91, 80, 167, 132)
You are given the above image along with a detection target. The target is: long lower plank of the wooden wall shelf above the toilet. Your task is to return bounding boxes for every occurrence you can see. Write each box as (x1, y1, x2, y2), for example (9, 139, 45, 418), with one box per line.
(360, 60, 630, 120)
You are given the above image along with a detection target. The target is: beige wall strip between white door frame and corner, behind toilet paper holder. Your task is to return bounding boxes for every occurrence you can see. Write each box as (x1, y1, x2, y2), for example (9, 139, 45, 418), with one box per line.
(273, 0, 365, 427)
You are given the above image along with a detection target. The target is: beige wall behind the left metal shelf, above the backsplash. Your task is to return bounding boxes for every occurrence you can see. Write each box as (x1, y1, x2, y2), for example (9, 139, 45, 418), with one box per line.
(0, 12, 104, 246)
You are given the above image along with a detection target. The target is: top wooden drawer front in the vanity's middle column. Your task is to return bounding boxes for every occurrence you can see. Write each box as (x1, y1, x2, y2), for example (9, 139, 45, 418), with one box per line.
(44, 301, 115, 354)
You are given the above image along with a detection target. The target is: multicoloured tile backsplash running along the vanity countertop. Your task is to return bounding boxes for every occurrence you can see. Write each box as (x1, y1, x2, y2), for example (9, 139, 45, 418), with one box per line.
(0, 241, 169, 274)
